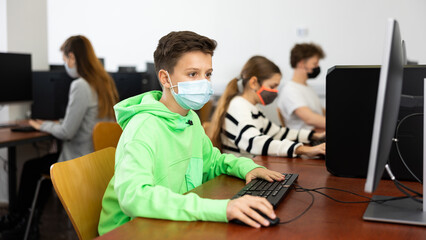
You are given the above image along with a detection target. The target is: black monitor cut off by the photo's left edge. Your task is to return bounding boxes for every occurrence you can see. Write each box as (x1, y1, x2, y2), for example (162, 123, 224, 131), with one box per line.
(0, 53, 33, 103)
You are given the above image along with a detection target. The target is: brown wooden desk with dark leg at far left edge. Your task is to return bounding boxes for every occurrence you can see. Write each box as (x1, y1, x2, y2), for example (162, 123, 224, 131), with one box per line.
(0, 124, 53, 211)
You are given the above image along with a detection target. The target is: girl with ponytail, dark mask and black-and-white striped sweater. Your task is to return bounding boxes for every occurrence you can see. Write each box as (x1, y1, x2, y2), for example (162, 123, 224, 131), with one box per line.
(209, 56, 325, 157)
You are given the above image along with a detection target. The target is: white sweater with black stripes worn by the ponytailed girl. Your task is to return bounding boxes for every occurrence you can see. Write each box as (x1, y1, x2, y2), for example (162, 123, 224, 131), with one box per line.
(221, 96, 314, 157)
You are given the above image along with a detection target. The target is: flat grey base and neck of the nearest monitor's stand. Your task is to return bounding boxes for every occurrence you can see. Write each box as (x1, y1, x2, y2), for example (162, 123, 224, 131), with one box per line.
(363, 78, 426, 226)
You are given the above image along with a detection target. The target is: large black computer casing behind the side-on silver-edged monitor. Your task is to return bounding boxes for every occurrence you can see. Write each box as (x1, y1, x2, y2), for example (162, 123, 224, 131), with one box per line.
(326, 65, 426, 180)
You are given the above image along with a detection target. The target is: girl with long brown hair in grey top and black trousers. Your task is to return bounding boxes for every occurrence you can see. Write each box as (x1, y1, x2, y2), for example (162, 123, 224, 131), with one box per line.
(0, 36, 118, 239)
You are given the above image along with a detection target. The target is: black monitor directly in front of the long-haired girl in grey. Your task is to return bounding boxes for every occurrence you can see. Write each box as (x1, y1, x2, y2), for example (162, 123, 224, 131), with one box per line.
(31, 71, 73, 120)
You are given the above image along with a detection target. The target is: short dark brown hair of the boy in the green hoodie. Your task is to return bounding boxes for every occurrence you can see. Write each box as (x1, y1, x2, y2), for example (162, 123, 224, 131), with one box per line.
(154, 31, 217, 73)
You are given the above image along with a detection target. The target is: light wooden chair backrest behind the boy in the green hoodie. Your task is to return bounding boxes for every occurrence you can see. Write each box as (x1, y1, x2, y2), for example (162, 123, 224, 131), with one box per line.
(50, 147, 115, 240)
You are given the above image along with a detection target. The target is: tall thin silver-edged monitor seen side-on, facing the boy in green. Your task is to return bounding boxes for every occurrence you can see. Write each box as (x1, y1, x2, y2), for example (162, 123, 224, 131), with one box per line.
(365, 19, 404, 192)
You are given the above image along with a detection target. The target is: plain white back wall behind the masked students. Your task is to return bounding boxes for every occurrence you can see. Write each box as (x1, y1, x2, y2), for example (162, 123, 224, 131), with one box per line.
(48, 0, 426, 93)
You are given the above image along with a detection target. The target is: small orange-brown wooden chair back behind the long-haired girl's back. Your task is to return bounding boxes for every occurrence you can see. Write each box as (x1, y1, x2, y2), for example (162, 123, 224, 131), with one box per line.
(92, 122, 123, 151)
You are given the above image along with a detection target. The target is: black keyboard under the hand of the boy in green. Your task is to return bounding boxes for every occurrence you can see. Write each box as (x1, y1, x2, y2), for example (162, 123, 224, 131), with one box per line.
(232, 173, 299, 208)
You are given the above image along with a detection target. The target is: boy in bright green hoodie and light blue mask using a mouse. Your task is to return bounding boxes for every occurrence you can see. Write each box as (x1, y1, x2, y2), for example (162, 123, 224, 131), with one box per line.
(98, 31, 284, 235)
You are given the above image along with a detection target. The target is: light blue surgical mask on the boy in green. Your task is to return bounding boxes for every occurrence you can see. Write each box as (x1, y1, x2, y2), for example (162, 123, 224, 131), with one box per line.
(167, 73, 213, 110)
